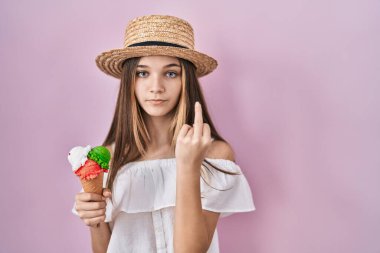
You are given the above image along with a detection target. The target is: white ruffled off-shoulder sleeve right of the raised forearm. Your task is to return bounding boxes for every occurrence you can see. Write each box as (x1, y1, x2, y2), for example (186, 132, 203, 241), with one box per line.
(201, 159, 256, 218)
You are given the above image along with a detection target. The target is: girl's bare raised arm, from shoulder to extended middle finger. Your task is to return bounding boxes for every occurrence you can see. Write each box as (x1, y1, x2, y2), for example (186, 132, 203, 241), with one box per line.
(174, 102, 233, 253)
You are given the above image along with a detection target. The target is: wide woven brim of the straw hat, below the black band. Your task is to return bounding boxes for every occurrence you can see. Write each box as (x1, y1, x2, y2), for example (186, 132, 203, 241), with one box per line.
(95, 46, 218, 79)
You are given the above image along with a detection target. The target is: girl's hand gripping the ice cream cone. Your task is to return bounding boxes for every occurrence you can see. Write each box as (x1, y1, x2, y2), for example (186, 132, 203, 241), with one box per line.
(75, 189, 112, 227)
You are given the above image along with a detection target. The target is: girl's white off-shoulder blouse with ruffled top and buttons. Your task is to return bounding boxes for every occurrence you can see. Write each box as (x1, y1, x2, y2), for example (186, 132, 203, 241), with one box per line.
(72, 158, 256, 253)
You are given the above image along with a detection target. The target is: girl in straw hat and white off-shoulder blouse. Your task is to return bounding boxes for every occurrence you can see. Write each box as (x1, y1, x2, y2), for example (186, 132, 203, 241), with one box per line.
(73, 15, 255, 253)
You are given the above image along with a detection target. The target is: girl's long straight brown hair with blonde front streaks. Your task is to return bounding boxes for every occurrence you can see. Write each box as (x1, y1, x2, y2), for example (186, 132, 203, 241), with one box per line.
(102, 57, 240, 194)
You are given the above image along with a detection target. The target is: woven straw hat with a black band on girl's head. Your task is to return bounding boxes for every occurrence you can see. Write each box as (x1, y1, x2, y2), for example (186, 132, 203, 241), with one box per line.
(96, 15, 218, 78)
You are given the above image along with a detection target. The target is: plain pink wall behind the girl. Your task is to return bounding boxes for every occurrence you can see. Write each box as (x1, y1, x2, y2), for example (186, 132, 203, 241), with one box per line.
(0, 0, 380, 253)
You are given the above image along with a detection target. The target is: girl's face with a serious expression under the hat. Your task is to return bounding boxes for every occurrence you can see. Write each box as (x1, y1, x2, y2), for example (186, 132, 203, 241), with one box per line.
(135, 56, 181, 117)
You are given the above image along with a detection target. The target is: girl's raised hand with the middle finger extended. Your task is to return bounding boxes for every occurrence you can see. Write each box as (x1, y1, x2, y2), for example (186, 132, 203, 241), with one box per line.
(175, 102, 212, 170)
